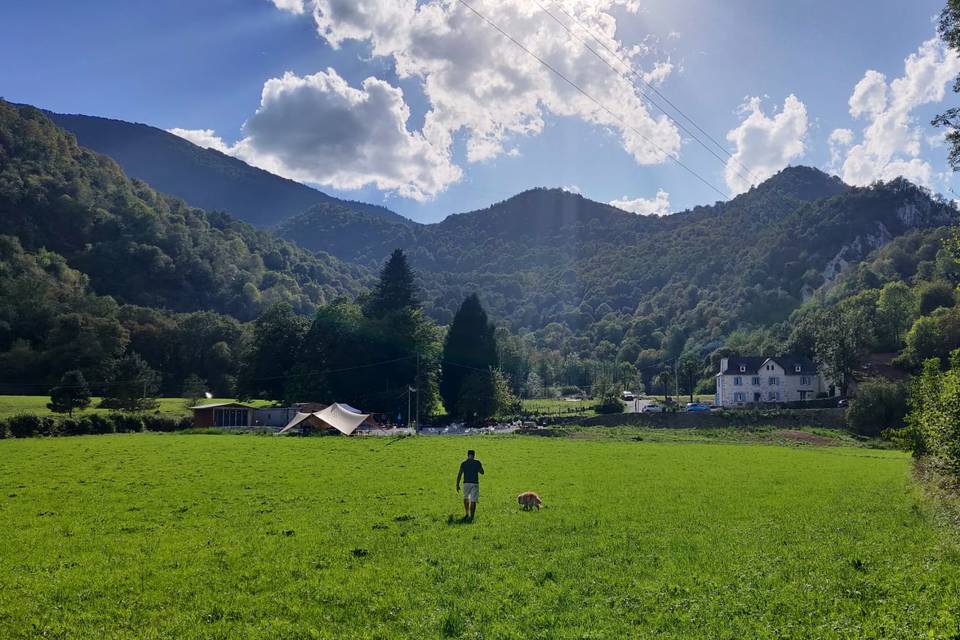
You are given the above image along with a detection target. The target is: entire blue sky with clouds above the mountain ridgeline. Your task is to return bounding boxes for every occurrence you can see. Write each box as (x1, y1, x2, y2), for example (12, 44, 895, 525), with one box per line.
(0, 0, 960, 221)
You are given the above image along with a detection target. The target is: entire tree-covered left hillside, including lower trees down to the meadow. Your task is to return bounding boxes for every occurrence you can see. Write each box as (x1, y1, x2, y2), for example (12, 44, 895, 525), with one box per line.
(0, 101, 370, 394)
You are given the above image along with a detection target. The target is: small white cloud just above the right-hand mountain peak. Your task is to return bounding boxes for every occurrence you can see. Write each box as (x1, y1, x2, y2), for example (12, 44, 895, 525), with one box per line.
(724, 94, 808, 193)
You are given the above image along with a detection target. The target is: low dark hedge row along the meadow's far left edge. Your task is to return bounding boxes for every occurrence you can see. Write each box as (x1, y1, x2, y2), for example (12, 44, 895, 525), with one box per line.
(0, 413, 192, 438)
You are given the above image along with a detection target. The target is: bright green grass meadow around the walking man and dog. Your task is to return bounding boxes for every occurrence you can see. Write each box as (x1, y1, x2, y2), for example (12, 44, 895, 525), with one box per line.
(0, 434, 960, 639)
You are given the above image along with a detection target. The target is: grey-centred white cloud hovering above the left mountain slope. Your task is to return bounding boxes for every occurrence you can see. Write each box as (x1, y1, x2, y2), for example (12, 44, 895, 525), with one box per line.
(171, 69, 461, 200)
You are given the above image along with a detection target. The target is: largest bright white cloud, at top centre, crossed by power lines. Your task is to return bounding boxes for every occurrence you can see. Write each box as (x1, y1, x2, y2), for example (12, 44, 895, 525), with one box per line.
(256, 0, 681, 195)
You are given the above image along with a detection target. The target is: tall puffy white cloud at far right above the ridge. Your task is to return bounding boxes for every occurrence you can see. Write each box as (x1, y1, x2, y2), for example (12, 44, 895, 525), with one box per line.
(831, 38, 960, 186)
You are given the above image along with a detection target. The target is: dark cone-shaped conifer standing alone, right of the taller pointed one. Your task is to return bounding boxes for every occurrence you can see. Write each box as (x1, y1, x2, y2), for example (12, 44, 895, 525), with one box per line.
(440, 294, 498, 418)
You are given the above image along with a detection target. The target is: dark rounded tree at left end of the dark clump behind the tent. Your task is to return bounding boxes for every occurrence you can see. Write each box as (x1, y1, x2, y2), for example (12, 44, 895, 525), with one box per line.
(238, 303, 310, 400)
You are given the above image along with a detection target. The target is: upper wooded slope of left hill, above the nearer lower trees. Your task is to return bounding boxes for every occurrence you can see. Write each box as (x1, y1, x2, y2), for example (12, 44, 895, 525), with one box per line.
(0, 102, 365, 320)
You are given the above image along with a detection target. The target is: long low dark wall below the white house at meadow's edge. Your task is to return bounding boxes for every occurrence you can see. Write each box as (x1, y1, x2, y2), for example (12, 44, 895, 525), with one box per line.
(578, 408, 847, 429)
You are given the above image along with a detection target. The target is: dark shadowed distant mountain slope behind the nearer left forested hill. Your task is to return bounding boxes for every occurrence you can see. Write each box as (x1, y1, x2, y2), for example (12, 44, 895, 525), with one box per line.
(47, 112, 405, 227)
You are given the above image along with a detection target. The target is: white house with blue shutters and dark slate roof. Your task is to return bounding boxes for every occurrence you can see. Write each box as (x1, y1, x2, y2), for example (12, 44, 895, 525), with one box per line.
(716, 356, 835, 407)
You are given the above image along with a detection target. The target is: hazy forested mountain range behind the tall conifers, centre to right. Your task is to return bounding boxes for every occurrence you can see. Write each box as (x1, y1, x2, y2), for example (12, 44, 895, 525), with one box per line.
(279, 167, 955, 362)
